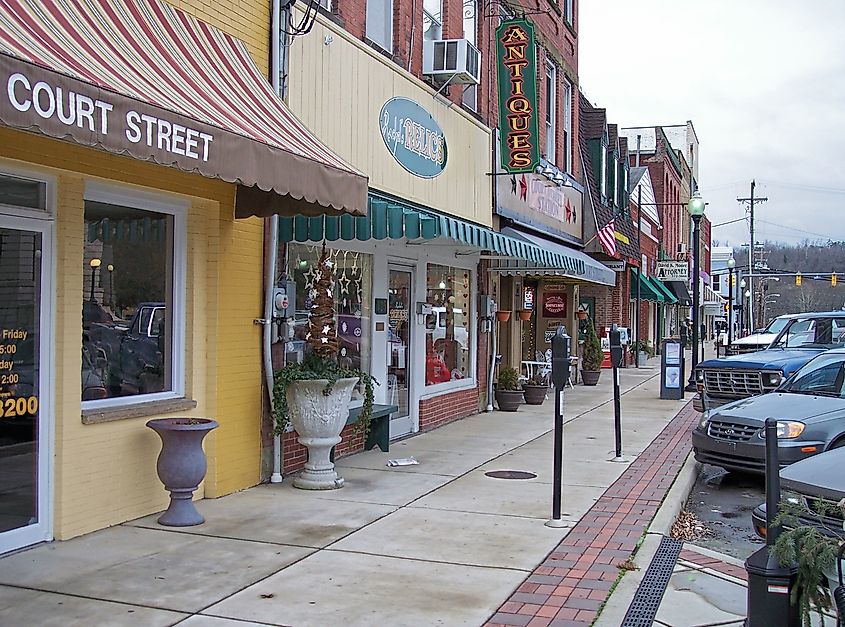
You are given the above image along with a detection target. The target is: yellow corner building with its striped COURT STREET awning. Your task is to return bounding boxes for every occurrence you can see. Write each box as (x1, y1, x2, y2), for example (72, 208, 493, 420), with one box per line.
(0, 0, 367, 553)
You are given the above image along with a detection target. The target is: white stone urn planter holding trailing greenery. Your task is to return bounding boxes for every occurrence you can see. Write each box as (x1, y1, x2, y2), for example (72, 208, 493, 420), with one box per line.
(286, 377, 358, 490)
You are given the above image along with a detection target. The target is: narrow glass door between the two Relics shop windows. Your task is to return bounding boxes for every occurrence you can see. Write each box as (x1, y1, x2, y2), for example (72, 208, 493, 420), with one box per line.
(387, 266, 414, 438)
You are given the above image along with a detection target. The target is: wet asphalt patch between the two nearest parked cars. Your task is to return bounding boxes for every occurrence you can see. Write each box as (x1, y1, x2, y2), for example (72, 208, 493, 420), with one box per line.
(687, 464, 766, 560)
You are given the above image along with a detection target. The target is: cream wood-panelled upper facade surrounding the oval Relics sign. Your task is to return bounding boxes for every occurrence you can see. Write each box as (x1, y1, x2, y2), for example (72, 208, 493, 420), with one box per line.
(288, 17, 492, 226)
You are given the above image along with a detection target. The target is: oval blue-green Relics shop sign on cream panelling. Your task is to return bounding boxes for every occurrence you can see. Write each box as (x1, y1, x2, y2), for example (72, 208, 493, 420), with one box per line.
(379, 97, 447, 179)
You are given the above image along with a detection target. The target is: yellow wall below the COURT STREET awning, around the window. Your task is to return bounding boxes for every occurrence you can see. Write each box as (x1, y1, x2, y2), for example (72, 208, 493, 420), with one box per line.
(0, 128, 263, 539)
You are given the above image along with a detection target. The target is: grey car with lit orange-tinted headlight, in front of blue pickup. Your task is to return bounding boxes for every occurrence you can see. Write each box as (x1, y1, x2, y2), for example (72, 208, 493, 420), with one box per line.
(692, 349, 845, 473)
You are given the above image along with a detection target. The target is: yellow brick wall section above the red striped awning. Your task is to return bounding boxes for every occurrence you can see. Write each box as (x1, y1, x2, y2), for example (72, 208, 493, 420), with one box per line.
(167, 0, 270, 76)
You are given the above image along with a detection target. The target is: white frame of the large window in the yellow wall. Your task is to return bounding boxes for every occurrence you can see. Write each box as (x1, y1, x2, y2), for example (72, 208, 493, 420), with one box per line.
(80, 181, 190, 410)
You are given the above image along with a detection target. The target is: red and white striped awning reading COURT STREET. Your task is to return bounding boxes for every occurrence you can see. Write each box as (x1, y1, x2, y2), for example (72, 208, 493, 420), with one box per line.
(0, 0, 367, 217)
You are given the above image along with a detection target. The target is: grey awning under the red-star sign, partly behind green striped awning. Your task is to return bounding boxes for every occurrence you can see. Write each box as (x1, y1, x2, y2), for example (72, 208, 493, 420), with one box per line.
(498, 227, 616, 286)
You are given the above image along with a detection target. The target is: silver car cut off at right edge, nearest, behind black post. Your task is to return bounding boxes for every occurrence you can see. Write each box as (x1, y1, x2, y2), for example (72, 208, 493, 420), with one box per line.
(751, 448, 845, 612)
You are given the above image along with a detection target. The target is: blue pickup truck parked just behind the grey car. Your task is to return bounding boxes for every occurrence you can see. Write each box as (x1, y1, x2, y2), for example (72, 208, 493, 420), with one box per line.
(693, 311, 845, 411)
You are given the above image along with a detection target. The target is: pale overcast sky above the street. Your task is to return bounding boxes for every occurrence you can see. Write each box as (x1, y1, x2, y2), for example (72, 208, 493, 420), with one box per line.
(578, 0, 845, 246)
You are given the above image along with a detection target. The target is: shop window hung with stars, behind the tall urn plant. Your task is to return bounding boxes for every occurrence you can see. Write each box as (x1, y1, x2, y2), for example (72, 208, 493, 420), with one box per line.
(286, 244, 373, 371)
